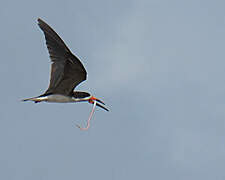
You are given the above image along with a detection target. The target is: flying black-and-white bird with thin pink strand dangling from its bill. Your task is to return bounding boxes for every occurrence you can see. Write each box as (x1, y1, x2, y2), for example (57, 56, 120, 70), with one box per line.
(23, 18, 109, 130)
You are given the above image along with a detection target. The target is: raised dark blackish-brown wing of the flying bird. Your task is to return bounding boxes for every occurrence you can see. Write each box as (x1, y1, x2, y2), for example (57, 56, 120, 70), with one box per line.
(38, 19, 87, 95)
